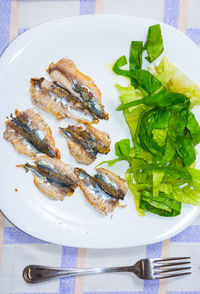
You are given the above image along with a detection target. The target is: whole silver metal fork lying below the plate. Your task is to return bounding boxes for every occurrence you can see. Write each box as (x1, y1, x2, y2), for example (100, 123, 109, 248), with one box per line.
(23, 257, 191, 284)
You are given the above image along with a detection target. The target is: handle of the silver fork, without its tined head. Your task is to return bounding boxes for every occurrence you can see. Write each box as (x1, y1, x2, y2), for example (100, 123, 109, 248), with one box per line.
(23, 265, 134, 284)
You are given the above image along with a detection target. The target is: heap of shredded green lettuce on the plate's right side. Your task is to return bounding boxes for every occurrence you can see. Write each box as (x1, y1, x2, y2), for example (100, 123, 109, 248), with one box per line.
(103, 25, 200, 217)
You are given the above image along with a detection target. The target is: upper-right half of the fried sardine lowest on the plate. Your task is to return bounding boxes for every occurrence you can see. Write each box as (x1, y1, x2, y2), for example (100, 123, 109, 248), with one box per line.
(94, 168, 128, 200)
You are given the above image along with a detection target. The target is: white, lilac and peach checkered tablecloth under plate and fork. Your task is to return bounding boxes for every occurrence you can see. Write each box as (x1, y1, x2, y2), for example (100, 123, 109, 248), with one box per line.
(0, 0, 200, 294)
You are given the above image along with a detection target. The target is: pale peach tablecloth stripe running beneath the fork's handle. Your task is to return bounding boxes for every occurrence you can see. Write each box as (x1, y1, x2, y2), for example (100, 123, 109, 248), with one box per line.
(74, 248, 86, 294)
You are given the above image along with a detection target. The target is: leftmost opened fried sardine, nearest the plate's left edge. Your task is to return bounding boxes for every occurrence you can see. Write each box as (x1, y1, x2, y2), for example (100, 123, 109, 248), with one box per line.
(3, 109, 60, 158)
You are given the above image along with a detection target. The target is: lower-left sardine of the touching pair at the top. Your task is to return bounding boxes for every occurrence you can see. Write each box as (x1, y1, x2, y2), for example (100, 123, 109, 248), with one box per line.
(30, 78, 98, 123)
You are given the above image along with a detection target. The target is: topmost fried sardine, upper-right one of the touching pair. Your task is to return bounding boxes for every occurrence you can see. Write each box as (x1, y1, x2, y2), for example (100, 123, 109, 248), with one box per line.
(47, 58, 109, 120)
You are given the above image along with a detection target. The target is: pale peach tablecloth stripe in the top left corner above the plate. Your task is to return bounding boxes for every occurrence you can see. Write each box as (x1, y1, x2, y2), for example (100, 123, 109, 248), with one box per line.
(9, 0, 20, 42)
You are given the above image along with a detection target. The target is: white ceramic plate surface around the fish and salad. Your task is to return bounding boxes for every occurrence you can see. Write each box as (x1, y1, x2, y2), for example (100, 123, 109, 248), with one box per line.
(0, 16, 200, 248)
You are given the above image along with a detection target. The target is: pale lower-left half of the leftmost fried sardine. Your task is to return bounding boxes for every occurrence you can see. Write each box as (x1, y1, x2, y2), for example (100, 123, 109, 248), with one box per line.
(3, 120, 38, 157)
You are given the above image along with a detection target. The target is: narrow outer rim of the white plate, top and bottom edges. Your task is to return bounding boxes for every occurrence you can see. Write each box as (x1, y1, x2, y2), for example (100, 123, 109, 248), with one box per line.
(0, 14, 200, 249)
